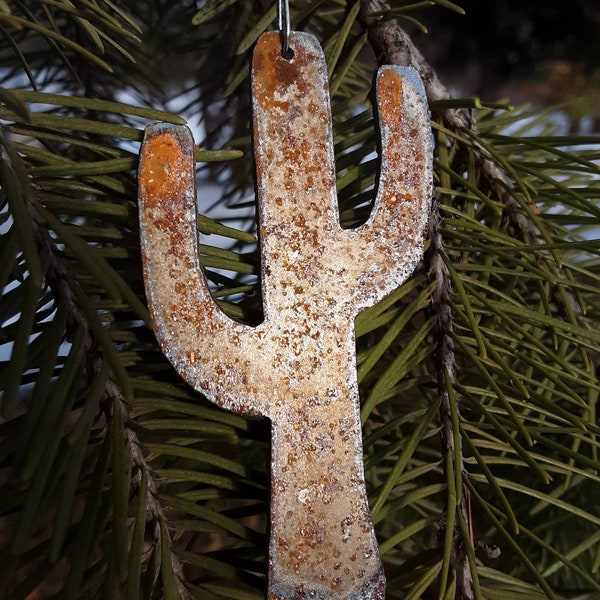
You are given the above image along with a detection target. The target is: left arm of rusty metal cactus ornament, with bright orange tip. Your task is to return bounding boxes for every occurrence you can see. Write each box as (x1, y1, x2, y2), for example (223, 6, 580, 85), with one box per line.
(138, 123, 263, 414)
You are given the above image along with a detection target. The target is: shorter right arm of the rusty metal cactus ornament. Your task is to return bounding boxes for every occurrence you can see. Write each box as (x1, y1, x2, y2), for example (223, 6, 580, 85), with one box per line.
(337, 66, 433, 308)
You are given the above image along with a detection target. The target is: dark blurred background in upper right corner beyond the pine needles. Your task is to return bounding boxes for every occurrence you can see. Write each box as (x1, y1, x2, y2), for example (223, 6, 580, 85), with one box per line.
(408, 0, 600, 130)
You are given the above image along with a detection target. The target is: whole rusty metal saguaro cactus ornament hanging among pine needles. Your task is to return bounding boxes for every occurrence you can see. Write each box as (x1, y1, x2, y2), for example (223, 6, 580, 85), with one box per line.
(139, 32, 432, 600)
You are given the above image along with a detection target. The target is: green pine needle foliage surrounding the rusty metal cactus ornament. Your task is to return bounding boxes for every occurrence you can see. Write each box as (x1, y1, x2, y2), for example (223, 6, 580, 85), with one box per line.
(0, 0, 600, 600)
